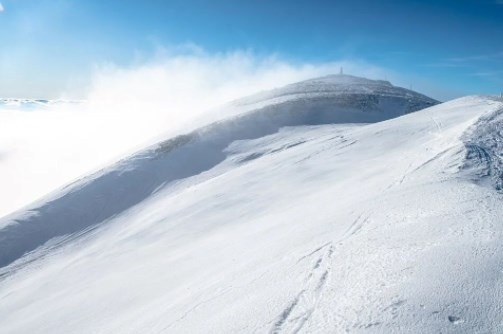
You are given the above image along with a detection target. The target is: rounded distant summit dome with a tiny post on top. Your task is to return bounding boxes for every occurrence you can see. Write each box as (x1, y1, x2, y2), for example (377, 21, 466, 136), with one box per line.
(233, 74, 439, 124)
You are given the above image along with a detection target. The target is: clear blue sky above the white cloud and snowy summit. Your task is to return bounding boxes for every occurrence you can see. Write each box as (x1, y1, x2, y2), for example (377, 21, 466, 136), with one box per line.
(0, 0, 503, 98)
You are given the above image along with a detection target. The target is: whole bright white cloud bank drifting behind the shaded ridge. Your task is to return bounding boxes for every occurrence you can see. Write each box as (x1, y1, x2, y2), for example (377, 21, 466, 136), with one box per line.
(0, 48, 383, 216)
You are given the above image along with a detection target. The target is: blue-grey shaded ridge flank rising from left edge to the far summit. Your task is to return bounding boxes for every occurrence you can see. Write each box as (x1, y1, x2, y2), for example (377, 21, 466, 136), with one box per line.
(0, 75, 436, 266)
